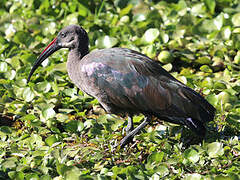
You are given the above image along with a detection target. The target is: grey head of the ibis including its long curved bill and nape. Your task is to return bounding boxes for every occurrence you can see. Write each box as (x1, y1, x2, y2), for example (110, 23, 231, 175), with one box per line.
(27, 25, 88, 82)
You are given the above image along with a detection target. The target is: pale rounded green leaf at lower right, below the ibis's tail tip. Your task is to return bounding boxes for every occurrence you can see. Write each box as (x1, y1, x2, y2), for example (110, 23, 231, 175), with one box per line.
(207, 142, 224, 158)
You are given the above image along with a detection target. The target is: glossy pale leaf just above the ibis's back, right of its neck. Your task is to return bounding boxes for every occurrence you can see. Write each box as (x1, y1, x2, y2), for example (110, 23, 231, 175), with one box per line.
(95, 36, 118, 48)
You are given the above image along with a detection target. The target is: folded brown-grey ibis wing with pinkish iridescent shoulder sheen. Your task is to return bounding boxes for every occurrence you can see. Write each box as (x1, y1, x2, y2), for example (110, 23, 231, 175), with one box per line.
(82, 48, 212, 122)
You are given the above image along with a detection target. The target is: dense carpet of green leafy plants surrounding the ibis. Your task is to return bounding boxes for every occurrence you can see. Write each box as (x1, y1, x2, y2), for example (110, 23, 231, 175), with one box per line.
(0, 0, 240, 180)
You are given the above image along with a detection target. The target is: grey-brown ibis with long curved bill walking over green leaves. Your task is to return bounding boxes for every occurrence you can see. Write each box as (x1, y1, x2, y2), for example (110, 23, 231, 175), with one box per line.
(27, 25, 215, 148)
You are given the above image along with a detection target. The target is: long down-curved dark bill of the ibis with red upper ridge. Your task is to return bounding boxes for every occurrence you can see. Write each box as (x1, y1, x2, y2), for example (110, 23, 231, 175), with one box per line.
(27, 38, 61, 82)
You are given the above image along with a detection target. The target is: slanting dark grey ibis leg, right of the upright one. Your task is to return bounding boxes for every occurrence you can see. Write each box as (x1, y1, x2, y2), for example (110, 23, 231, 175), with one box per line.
(120, 116, 149, 148)
